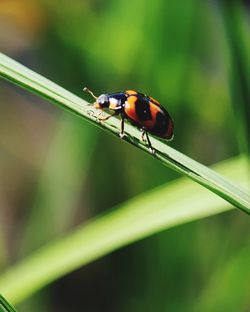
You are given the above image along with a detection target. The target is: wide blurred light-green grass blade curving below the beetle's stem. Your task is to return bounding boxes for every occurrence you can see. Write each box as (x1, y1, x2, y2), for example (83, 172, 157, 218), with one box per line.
(0, 157, 249, 304)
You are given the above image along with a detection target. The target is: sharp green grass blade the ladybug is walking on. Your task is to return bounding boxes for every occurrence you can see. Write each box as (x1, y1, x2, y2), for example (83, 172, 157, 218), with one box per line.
(0, 53, 250, 214)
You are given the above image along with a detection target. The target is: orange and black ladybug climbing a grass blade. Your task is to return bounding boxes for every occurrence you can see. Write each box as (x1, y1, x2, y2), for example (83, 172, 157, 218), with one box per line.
(83, 87, 174, 153)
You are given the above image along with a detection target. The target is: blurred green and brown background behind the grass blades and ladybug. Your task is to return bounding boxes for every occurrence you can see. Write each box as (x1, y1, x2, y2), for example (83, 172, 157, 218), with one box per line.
(0, 0, 250, 312)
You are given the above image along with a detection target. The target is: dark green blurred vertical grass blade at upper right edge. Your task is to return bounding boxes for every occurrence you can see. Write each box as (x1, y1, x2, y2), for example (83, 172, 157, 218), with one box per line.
(220, 0, 250, 153)
